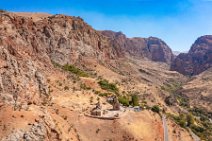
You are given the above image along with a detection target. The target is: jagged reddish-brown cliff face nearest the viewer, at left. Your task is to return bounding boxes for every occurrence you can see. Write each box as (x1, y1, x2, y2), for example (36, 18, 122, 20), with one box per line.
(0, 12, 118, 104)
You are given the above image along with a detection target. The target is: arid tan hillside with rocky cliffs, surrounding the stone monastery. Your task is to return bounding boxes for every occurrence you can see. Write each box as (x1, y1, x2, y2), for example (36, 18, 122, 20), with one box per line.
(0, 12, 211, 141)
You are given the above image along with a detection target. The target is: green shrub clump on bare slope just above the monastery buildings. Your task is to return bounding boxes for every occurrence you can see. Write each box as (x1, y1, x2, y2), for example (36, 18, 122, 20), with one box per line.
(98, 80, 118, 94)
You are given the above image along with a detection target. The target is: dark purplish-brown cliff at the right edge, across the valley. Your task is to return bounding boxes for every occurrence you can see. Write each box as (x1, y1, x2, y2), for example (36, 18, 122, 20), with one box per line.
(171, 35, 212, 75)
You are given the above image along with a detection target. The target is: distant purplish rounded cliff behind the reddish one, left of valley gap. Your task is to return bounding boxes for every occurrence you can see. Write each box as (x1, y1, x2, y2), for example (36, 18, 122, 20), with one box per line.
(102, 31, 174, 64)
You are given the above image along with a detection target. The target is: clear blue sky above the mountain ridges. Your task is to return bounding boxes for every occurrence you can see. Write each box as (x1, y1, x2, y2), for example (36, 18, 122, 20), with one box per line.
(0, 0, 212, 51)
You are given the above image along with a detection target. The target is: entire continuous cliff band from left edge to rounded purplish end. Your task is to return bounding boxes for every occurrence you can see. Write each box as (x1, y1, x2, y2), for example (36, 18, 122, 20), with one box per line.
(0, 12, 176, 104)
